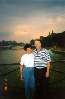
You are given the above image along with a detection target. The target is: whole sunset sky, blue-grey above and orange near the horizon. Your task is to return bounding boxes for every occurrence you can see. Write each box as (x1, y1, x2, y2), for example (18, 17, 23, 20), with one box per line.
(0, 0, 65, 42)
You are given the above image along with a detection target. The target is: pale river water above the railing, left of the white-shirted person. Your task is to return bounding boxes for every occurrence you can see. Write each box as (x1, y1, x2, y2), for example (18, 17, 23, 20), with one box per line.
(0, 49, 25, 64)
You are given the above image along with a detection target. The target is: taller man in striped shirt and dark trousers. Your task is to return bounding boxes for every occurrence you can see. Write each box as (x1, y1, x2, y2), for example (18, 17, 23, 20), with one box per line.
(33, 39, 51, 99)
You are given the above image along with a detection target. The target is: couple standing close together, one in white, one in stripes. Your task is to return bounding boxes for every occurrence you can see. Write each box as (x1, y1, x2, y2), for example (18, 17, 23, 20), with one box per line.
(19, 39, 51, 99)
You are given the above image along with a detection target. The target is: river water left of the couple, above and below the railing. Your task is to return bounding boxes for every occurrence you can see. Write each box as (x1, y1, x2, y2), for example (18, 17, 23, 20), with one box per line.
(0, 49, 25, 85)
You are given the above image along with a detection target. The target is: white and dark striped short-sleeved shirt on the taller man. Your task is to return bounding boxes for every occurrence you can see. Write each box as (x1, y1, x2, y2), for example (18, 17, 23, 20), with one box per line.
(33, 48, 51, 68)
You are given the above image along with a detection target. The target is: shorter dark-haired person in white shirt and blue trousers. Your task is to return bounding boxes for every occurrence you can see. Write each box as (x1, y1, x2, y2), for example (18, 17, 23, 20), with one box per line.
(20, 44, 35, 99)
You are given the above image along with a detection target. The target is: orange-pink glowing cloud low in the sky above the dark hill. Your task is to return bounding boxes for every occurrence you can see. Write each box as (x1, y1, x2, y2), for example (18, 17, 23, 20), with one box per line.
(9, 15, 65, 41)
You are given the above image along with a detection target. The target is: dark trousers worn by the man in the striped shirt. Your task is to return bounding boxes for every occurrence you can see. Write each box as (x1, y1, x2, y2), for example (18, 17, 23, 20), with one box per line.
(34, 67, 48, 99)
